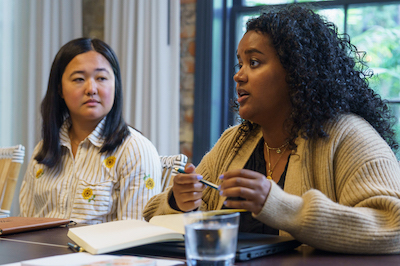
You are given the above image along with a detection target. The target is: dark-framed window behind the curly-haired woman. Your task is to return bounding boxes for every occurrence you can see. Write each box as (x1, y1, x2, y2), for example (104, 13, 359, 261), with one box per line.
(193, 0, 400, 164)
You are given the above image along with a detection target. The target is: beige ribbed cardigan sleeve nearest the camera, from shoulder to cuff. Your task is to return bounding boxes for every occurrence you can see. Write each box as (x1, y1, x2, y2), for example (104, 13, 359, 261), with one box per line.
(255, 116, 400, 254)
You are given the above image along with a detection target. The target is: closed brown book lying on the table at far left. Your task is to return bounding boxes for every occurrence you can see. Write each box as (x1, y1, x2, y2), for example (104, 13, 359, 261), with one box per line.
(0, 217, 71, 235)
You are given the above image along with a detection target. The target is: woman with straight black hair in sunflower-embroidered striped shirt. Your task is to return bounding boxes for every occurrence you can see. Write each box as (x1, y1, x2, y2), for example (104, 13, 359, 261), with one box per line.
(20, 38, 161, 224)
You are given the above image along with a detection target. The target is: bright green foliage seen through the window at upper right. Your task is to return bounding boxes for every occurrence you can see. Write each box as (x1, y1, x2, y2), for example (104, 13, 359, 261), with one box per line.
(347, 5, 400, 152)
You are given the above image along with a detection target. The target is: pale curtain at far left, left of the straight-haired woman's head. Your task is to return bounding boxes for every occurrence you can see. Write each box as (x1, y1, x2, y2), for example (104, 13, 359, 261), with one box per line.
(0, 0, 82, 215)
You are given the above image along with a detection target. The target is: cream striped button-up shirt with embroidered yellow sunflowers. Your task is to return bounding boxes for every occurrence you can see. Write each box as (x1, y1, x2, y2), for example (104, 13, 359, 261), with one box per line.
(19, 119, 162, 224)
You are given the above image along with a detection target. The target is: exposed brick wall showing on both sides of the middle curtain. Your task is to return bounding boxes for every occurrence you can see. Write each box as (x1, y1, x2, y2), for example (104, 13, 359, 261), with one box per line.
(82, 0, 196, 161)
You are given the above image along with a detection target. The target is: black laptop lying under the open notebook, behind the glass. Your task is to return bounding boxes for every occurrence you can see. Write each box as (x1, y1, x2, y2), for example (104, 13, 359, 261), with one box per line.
(115, 232, 301, 261)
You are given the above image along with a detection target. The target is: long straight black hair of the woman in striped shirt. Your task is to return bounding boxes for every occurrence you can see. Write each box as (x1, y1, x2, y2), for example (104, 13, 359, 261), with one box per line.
(35, 38, 129, 168)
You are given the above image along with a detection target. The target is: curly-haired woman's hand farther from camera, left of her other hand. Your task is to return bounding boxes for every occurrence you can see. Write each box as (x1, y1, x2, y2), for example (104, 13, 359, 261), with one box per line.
(172, 164, 206, 212)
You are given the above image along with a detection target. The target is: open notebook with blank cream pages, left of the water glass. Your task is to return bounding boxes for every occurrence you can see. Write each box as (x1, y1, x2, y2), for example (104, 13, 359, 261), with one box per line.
(67, 214, 184, 254)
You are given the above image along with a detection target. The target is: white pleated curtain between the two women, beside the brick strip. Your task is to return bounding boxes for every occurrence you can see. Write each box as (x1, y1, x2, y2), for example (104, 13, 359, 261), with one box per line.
(104, 0, 180, 155)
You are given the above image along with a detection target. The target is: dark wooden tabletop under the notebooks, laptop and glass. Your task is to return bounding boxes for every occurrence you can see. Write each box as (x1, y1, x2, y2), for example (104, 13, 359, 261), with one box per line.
(0, 227, 400, 266)
